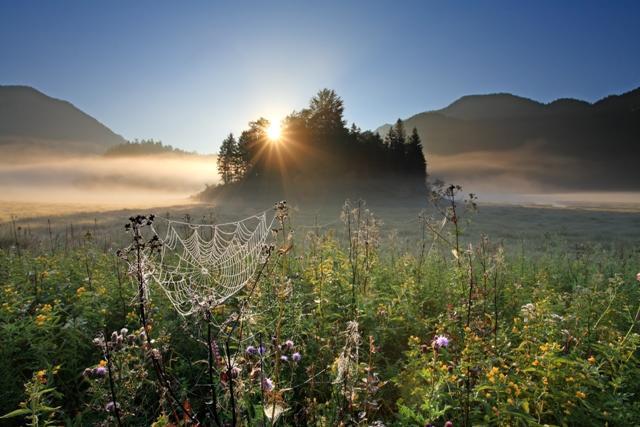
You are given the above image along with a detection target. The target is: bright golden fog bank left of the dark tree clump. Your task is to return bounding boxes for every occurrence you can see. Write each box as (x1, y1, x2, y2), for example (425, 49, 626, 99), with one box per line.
(0, 155, 218, 216)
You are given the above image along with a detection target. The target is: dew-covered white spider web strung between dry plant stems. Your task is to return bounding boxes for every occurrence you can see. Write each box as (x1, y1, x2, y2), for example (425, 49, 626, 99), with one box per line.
(150, 211, 275, 316)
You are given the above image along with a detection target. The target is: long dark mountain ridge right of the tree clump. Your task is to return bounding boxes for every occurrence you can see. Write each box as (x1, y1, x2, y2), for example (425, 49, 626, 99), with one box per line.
(377, 88, 640, 190)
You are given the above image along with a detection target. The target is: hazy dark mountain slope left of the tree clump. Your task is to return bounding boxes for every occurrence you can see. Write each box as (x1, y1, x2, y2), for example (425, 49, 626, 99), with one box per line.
(0, 86, 125, 154)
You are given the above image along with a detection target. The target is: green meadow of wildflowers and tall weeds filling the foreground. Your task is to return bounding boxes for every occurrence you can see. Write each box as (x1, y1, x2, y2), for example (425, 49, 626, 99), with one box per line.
(0, 198, 640, 427)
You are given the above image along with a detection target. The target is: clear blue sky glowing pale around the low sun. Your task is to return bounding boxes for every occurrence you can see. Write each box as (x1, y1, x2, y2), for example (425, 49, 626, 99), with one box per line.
(0, 0, 640, 153)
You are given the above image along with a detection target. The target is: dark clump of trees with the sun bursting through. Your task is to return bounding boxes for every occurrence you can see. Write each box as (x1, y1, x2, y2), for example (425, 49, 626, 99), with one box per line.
(217, 89, 427, 184)
